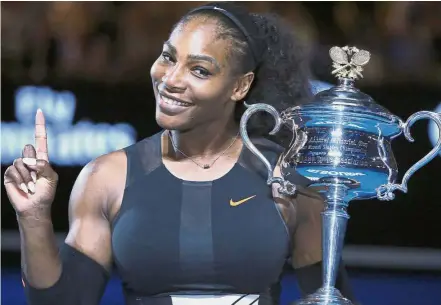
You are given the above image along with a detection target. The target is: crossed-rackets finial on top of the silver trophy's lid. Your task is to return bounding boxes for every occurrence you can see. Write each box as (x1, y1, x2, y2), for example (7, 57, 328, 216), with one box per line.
(329, 46, 371, 80)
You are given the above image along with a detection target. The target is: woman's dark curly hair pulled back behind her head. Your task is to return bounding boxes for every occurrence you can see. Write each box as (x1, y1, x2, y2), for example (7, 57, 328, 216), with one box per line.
(178, 3, 312, 144)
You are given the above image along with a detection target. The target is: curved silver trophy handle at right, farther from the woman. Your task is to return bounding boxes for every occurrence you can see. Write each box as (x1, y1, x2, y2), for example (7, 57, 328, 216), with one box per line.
(377, 111, 441, 200)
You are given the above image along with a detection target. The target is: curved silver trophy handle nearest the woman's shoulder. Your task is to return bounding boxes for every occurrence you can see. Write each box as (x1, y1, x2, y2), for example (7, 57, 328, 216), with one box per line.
(240, 103, 296, 195)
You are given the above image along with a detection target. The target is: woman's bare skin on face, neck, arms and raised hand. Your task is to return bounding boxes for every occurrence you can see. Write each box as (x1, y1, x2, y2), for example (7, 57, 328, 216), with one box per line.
(5, 19, 323, 288)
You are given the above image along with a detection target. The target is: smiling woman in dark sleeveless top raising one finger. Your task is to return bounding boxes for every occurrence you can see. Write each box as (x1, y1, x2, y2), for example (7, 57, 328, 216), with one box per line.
(5, 3, 351, 305)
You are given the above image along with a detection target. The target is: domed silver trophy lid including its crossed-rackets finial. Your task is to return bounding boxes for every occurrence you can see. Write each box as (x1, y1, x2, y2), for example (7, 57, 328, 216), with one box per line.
(291, 46, 401, 135)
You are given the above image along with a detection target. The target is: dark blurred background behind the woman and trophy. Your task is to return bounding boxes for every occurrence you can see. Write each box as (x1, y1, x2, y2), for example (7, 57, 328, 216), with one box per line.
(1, 1, 441, 305)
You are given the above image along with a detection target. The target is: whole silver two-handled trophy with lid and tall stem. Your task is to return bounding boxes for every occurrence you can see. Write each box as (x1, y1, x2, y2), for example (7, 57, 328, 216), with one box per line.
(240, 46, 441, 305)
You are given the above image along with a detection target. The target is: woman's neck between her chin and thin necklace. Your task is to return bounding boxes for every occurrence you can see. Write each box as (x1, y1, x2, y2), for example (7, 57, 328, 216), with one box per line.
(169, 122, 239, 158)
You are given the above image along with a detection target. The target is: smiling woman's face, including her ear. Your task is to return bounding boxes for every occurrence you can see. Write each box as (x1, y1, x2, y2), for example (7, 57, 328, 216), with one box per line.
(150, 18, 252, 131)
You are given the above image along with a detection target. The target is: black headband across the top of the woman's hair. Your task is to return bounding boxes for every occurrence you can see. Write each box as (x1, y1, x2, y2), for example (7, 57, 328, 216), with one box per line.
(187, 4, 263, 67)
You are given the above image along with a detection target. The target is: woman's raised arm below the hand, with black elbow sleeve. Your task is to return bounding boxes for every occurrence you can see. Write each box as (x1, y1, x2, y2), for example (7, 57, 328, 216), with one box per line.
(19, 153, 125, 305)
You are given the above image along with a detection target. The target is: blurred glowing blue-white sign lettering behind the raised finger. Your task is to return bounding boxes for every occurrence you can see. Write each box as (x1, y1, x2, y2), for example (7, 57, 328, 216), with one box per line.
(1, 86, 136, 166)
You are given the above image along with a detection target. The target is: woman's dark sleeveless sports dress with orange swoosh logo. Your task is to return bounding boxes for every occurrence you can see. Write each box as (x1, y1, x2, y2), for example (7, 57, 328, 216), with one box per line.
(112, 133, 309, 305)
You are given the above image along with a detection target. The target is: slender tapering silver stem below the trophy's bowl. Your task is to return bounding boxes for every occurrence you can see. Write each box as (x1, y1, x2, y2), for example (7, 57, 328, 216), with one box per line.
(322, 184, 349, 289)
